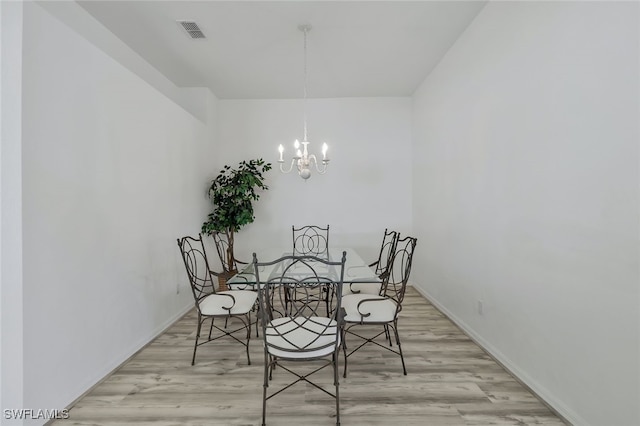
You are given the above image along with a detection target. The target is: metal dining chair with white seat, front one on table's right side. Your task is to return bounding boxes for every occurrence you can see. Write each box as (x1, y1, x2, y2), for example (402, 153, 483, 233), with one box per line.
(342, 237, 418, 377)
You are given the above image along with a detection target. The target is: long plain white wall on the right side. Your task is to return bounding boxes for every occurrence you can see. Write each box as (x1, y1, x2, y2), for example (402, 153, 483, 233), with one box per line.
(413, 2, 640, 426)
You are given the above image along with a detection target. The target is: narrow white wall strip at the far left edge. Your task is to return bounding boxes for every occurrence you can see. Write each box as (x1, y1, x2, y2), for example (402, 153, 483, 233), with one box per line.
(0, 1, 24, 422)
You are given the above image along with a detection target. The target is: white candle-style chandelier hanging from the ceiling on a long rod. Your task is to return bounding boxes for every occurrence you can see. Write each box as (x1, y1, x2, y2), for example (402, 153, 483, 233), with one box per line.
(278, 25, 329, 179)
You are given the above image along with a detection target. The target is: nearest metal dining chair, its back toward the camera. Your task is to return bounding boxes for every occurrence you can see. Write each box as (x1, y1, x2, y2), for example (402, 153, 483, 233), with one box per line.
(253, 252, 346, 426)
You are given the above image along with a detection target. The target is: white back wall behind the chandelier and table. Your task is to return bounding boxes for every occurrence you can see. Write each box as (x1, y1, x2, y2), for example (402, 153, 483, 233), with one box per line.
(216, 98, 411, 259)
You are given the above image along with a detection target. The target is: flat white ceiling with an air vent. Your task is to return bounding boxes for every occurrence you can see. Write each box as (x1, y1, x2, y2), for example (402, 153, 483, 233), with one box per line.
(78, 0, 486, 99)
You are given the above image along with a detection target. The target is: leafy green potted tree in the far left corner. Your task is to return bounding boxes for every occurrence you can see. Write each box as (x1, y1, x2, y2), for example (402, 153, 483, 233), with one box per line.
(202, 158, 271, 287)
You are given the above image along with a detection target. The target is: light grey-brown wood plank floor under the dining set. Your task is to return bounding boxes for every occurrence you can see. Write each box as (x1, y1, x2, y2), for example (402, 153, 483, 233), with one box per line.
(52, 288, 565, 426)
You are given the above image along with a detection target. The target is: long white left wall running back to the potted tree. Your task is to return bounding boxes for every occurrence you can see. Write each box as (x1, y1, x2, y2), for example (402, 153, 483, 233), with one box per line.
(16, 3, 217, 420)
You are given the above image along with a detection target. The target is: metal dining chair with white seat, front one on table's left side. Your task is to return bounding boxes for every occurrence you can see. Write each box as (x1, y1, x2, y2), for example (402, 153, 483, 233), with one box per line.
(178, 235, 258, 365)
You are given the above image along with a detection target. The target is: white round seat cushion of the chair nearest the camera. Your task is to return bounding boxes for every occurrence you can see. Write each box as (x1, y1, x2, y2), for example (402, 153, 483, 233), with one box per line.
(265, 317, 340, 358)
